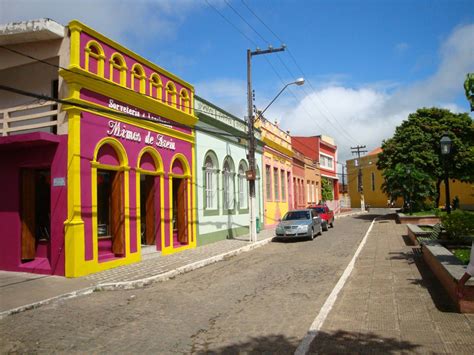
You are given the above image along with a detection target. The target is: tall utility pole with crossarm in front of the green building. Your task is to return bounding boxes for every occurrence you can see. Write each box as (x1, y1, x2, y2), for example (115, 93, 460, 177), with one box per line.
(246, 45, 286, 242)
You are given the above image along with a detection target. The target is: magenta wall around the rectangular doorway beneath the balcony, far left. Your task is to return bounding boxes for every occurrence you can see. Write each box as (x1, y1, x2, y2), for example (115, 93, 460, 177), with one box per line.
(0, 132, 67, 275)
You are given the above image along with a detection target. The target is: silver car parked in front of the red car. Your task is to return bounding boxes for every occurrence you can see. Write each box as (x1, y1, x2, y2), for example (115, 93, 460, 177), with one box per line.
(275, 209, 323, 239)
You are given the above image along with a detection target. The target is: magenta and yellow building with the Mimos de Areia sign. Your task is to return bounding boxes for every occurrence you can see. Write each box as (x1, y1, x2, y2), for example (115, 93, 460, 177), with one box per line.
(0, 20, 197, 277)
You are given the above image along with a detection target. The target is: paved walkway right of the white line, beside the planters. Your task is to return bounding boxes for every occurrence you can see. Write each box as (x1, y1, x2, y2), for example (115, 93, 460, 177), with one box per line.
(309, 218, 474, 354)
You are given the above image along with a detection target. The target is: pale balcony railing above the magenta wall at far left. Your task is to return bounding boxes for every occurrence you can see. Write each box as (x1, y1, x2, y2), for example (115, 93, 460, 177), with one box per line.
(0, 101, 58, 136)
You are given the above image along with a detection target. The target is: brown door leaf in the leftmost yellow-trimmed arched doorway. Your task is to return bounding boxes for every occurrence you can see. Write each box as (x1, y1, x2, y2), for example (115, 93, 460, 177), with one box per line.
(110, 172, 125, 255)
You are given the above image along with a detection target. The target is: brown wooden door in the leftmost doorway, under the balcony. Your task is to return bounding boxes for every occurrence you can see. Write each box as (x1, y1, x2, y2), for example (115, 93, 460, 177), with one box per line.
(21, 169, 36, 261)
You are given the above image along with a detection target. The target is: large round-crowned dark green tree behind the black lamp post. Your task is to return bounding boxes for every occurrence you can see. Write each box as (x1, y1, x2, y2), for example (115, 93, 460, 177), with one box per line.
(377, 107, 474, 208)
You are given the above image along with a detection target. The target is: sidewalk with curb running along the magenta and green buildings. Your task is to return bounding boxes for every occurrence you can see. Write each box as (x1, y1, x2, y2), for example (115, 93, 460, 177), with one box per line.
(0, 229, 274, 319)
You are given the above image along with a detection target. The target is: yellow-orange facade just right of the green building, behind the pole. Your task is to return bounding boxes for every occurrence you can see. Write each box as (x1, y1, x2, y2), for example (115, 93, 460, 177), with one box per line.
(255, 118, 294, 227)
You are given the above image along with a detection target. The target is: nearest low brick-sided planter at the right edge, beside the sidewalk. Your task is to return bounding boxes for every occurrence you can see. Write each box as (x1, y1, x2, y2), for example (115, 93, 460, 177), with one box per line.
(422, 241, 474, 313)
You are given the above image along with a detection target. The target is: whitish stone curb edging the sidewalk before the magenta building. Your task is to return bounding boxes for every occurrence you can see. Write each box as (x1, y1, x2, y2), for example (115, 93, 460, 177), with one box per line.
(0, 237, 273, 319)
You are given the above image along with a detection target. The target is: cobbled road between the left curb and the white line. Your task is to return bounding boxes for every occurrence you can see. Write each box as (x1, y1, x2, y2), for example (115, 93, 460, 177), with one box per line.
(0, 215, 373, 353)
